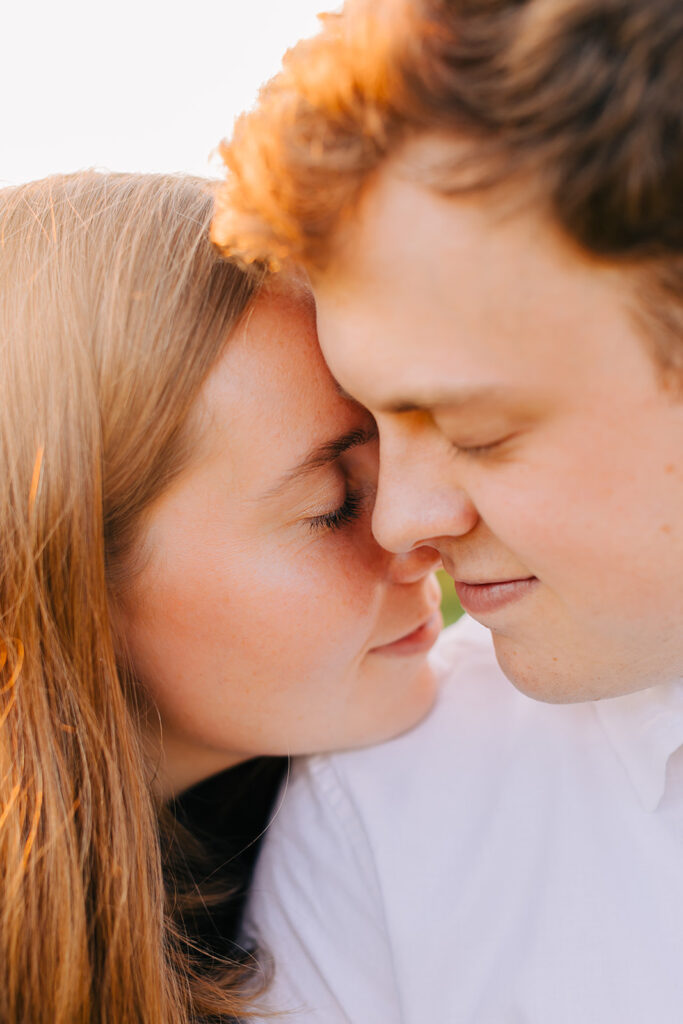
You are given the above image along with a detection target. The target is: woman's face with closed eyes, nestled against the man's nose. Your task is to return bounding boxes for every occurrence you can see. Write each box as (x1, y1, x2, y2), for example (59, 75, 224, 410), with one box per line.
(123, 287, 441, 795)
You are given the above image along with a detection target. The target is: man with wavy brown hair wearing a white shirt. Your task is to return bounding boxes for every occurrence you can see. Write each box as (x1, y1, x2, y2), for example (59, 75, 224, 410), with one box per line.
(214, 0, 683, 1024)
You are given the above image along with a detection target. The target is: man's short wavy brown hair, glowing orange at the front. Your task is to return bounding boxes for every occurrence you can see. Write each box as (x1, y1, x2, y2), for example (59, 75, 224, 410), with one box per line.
(212, 0, 683, 369)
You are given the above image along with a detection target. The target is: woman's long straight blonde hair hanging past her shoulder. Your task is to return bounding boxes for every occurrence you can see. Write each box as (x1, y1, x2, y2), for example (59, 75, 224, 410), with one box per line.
(0, 172, 266, 1024)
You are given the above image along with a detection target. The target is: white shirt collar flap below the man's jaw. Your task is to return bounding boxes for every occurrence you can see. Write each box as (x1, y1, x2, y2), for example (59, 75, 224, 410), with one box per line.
(595, 679, 683, 811)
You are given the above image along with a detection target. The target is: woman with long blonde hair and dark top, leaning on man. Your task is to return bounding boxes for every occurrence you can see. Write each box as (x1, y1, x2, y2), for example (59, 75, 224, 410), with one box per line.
(0, 173, 439, 1024)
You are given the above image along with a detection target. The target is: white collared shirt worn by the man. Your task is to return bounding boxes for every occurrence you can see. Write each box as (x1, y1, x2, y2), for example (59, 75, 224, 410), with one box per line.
(247, 620, 683, 1024)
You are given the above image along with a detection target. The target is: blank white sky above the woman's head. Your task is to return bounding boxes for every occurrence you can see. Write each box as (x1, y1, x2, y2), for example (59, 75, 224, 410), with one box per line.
(0, 0, 327, 184)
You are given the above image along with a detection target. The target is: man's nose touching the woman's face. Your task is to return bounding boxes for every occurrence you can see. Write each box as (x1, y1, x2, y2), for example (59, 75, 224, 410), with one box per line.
(373, 416, 479, 553)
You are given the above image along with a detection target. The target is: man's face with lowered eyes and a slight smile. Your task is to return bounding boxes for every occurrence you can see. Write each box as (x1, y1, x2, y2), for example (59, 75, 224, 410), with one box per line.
(315, 148, 683, 701)
